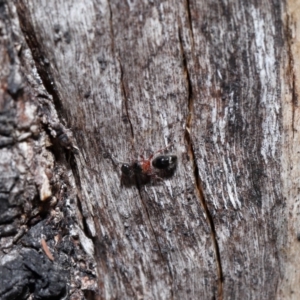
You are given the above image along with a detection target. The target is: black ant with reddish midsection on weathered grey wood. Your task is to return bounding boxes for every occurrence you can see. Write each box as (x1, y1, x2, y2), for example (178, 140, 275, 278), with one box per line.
(121, 148, 177, 185)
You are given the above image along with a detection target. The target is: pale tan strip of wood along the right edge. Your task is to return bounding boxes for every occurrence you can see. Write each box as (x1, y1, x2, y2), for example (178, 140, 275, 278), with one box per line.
(277, 1, 300, 299)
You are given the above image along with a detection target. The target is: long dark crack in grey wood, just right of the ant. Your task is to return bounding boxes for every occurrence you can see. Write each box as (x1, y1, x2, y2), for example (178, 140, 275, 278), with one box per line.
(178, 29, 223, 300)
